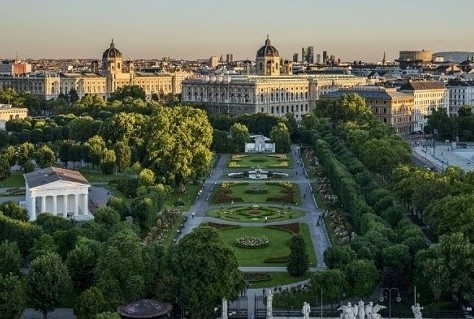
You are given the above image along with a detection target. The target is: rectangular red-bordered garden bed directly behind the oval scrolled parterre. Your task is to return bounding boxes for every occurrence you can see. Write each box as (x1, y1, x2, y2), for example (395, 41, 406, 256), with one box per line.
(213, 182, 301, 204)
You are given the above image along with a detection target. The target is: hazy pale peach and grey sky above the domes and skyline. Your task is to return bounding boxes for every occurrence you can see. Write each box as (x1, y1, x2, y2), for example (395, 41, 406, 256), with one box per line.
(0, 0, 474, 61)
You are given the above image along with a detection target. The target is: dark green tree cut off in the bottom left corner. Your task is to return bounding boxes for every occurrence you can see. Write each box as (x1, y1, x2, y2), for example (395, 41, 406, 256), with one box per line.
(0, 273, 26, 319)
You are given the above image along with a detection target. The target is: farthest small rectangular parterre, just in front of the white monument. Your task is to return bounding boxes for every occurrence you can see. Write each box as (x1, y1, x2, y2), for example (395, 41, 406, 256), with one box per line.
(227, 154, 291, 169)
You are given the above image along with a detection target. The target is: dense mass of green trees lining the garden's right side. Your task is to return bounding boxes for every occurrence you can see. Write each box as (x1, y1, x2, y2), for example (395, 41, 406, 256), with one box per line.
(303, 92, 474, 300)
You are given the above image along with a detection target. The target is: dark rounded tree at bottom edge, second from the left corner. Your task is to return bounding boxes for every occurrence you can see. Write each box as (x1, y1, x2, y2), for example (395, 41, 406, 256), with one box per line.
(26, 253, 71, 319)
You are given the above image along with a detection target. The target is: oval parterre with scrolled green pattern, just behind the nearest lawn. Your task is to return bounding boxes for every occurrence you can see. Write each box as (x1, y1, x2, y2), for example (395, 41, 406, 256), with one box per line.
(206, 205, 304, 223)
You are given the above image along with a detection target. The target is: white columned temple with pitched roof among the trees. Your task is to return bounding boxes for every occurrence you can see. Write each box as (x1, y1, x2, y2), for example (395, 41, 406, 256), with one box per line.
(24, 167, 93, 221)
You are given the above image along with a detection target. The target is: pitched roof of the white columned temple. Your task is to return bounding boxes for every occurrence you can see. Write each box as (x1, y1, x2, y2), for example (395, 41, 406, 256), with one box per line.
(24, 167, 89, 188)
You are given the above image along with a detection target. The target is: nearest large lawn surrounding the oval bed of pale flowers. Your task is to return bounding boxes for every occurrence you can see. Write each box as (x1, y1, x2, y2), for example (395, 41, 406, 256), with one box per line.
(219, 225, 316, 267)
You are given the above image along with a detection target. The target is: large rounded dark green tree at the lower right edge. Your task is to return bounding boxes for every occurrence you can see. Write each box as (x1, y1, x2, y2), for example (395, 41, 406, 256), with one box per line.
(423, 233, 474, 300)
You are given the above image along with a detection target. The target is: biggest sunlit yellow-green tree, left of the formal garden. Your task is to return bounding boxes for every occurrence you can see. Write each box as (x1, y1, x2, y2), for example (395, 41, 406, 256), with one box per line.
(147, 106, 212, 193)
